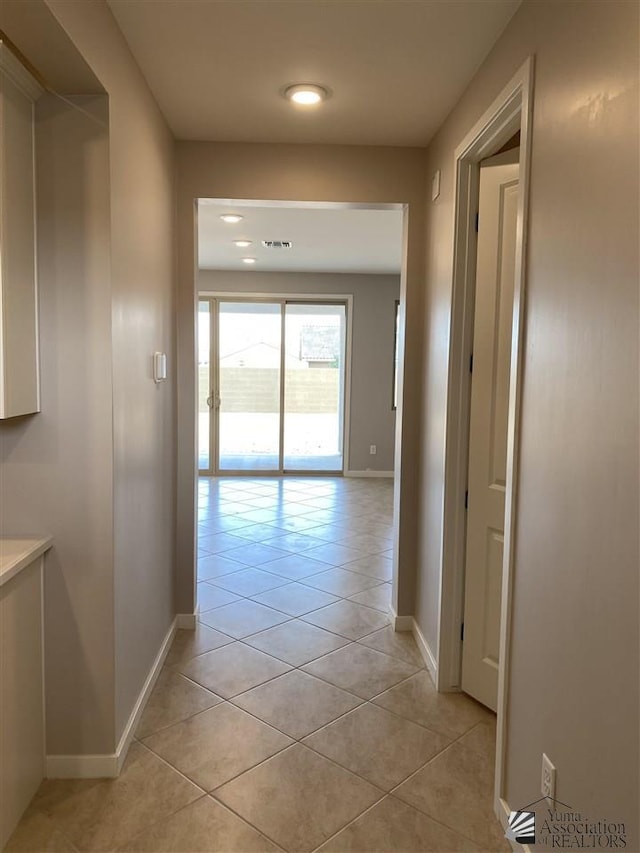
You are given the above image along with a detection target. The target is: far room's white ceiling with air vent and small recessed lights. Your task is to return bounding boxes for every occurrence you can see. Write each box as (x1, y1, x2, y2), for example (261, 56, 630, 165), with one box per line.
(198, 199, 402, 274)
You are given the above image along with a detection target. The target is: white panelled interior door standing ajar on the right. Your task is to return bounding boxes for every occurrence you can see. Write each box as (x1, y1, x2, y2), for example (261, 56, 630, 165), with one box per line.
(462, 149, 519, 711)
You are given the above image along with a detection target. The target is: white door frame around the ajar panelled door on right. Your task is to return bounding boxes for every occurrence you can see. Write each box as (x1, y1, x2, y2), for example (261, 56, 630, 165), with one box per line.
(436, 57, 534, 825)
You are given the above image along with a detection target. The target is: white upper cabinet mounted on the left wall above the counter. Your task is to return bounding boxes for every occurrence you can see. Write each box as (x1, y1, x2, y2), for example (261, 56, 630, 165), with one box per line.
(0, 41, 42, 418)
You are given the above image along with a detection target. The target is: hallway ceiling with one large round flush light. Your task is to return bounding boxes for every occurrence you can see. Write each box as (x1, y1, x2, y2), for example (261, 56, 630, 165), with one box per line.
(109, 0, 520, 146)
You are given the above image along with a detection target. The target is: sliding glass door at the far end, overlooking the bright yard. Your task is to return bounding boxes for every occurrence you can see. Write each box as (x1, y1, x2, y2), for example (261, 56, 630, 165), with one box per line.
(198, 297, 347, 474)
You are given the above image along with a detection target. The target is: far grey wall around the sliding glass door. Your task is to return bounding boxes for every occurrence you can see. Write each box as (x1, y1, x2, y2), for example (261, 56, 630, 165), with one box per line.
(198, 270, 400, 471)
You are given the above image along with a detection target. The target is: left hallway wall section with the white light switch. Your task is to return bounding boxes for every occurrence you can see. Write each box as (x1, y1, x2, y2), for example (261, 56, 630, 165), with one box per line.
(43, 0, 175, 738)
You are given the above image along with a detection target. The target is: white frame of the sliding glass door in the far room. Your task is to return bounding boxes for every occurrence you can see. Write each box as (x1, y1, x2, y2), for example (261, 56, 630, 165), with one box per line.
(197, 290, 353, 477)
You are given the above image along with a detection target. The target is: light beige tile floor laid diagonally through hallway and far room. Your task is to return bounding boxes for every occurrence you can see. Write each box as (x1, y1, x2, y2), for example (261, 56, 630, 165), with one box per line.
(6, 477, 510, 853)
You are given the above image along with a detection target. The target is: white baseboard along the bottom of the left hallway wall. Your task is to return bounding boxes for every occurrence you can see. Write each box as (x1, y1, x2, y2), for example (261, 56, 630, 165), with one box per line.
(46, 614, 178, 779)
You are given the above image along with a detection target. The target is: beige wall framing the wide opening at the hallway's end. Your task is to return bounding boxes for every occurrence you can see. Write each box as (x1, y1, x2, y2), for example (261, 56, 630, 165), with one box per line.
(176, 142, 425, 613)
